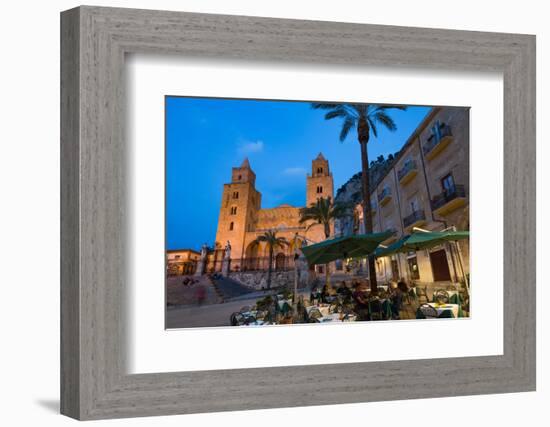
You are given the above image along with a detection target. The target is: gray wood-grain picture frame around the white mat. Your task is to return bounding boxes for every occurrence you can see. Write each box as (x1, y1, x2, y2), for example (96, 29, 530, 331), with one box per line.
(61, 6, 536, 420)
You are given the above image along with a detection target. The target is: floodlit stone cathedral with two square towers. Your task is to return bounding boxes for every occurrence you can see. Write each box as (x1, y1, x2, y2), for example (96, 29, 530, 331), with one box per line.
(215, 153, 334, 271)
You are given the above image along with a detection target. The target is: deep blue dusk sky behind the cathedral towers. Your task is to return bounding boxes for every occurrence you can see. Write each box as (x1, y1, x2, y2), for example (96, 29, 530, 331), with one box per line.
(165, 96, 430, 250)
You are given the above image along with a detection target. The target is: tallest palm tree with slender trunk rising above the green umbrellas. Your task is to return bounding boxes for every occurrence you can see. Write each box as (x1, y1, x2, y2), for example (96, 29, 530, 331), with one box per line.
(311, 103, 407, 293)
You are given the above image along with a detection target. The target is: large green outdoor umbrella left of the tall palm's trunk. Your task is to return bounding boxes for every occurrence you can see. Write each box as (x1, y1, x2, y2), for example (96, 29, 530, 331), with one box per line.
(302, 231, 393, 265)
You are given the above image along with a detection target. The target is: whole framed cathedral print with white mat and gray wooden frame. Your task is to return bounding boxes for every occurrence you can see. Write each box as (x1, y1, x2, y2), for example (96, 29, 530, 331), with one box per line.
(61, 6, 535, 419)
